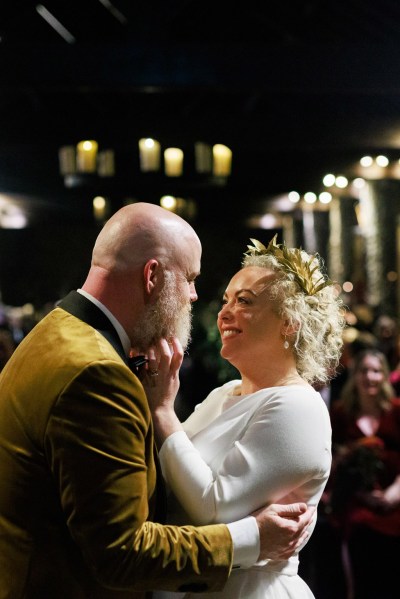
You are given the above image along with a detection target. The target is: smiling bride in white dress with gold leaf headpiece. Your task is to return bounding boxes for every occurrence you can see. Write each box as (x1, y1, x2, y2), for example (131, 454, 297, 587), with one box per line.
(143, 236, 344, 599)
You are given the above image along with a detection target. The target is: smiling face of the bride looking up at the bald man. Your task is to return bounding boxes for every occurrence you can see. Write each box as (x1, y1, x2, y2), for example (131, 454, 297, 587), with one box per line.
(218, 266, 283, 367)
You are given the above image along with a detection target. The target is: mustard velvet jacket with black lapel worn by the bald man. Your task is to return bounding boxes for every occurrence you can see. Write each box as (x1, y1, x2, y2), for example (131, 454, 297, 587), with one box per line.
(0, 292, 232, 599)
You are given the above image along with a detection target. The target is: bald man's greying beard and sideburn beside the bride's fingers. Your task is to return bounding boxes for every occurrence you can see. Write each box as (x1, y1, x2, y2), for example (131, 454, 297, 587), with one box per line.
(132, 271, 192, 353)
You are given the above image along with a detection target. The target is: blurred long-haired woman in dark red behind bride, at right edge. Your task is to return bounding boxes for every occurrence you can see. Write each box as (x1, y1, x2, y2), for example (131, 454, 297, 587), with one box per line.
(328, 349, 400, 599)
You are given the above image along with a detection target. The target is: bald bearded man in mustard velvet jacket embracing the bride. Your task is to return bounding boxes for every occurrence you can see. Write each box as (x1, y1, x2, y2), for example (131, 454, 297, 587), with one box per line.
(0, 203, 312, 599)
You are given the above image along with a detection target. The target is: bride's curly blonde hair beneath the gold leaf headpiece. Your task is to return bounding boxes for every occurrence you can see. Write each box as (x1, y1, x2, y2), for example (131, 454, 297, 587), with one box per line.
(242, 248, 346, 384)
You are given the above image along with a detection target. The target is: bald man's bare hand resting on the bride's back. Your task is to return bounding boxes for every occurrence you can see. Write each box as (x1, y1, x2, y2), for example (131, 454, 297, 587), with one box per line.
(251, 503, 315, 560)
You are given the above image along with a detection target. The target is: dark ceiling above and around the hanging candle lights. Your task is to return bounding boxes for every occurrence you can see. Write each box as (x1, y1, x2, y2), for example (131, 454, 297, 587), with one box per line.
(0, 0, 400, 225)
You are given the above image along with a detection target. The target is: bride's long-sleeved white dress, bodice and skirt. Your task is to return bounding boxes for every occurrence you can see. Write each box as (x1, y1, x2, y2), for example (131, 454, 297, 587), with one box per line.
(154, 381, 331, 599)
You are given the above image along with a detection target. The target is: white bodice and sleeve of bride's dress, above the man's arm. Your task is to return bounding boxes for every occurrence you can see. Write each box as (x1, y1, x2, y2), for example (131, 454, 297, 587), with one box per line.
(160, 386, 331, 524)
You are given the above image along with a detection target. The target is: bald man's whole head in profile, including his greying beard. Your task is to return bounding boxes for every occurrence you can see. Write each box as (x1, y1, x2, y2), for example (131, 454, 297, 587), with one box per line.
(82, 202, 201, 352)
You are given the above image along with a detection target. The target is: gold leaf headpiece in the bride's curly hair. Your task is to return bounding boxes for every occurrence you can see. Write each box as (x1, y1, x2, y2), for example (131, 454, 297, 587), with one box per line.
(245, 235, 333, 295)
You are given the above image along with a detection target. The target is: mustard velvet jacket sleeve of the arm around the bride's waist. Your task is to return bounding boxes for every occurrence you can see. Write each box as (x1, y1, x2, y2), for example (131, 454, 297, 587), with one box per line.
(45, 361, 231, 590)
